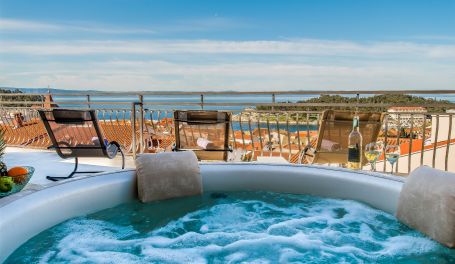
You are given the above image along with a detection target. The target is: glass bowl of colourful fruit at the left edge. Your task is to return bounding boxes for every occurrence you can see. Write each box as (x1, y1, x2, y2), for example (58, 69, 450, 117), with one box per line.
(0, 166, 35, 198)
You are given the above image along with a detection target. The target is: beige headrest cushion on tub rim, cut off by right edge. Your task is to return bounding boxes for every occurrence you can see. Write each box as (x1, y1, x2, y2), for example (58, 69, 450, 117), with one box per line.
(397, 166, 455, 248)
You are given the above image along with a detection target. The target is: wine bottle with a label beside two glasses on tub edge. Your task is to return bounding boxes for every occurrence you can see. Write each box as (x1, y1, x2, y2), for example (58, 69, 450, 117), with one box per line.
(347, 116, 362, 170)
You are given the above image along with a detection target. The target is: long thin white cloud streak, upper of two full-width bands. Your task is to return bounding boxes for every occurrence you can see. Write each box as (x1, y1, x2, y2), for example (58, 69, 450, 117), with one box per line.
(0, 39, 455, 59)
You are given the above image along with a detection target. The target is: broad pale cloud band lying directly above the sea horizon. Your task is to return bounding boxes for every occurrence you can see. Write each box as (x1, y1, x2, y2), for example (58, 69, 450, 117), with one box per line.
(0, 60, 455, 91)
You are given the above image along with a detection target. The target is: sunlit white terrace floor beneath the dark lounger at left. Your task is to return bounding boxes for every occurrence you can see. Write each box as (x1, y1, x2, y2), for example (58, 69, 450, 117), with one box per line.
(4, 147, 134, 188)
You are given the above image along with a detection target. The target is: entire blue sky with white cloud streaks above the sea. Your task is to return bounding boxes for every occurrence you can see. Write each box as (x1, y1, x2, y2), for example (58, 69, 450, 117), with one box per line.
(0, 0, 455, 91)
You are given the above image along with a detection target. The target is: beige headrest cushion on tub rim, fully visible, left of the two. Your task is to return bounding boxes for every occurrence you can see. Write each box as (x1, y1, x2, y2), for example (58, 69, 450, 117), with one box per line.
(136, 151, 202, 202)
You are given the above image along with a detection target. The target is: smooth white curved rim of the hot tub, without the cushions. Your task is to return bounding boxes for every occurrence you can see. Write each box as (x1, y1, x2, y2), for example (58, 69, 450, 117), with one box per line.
(0, 163, 403, 262)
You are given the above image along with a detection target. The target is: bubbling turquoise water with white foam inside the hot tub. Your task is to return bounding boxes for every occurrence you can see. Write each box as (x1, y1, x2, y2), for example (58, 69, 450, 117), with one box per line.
(7, 192, 455, 263)
